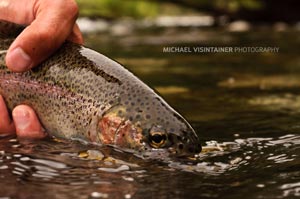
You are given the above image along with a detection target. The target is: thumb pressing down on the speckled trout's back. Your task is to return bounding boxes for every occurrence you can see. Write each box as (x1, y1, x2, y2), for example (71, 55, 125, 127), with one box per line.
(6, 1, 81, 72)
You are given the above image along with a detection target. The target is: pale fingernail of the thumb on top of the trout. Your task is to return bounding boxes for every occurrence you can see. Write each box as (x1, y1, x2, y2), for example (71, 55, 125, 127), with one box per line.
(8, 47, 32, 72)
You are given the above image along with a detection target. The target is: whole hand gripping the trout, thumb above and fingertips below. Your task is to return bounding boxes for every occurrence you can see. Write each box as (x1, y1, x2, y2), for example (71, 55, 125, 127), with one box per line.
(0, 0, 83, 138)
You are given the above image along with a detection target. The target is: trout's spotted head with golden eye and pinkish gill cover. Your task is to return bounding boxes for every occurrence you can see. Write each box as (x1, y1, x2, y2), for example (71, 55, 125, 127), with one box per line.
(98, 98, 201, 156)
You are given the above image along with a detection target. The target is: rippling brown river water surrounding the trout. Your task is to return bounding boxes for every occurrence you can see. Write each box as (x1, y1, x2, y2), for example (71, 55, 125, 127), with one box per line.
(0, 28, 300, 199)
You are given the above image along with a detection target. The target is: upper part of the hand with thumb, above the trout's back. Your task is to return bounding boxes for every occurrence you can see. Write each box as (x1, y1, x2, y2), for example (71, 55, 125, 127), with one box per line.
(0, 0, 83, 72)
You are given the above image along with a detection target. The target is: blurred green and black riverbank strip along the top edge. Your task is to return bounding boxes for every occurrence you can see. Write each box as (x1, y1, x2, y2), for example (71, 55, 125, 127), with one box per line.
(77, 0, 300, 23)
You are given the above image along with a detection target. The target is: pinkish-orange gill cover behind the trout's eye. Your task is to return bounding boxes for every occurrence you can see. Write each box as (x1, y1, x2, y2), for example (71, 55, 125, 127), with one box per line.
(98, 113, 144, 151)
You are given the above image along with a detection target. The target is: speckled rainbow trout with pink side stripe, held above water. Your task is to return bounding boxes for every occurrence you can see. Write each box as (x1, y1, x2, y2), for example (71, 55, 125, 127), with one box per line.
(0, 21, 201, 155)
